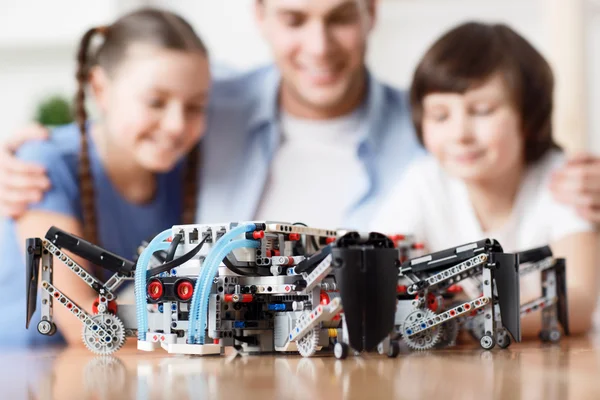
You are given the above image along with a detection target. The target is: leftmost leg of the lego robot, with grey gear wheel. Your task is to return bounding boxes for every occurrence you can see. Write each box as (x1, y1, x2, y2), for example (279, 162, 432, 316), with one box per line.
(25, 227, 136, 354)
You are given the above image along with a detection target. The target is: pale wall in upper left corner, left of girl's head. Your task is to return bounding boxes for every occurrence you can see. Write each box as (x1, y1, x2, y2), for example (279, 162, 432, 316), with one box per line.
(0, 0, 137, 140)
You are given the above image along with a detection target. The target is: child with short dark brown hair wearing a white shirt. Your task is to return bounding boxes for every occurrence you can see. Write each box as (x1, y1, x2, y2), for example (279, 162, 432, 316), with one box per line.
(373, 23, 598, 336)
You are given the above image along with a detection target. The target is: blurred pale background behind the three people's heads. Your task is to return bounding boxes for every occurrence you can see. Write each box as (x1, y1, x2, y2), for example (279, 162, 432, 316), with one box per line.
(0, 0, 600, 152)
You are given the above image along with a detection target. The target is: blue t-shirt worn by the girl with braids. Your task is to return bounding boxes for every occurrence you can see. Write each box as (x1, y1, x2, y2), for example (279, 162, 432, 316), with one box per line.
(0, 124, 183, 347)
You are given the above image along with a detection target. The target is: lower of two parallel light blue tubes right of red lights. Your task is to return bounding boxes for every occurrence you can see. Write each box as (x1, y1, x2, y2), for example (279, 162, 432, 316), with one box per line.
(189, 239, 259, 344)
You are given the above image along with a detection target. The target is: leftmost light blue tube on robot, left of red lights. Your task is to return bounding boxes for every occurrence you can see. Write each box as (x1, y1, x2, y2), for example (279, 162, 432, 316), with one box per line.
(134, 229, 171, 340)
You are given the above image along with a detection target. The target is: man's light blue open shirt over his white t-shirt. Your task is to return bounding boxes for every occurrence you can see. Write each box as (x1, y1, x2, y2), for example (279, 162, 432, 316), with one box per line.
(197, 66, 424, 230)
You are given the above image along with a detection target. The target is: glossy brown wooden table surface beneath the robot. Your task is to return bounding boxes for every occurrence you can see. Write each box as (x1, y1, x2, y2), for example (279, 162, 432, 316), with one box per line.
(0, 334, 600, 400)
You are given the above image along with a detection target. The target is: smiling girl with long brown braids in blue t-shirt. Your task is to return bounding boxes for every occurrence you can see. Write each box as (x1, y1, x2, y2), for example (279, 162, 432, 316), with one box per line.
(0, 9, 210, 346)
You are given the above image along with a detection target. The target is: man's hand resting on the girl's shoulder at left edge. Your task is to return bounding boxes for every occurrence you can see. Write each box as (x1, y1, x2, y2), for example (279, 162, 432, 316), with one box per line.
(0, 124, 50, 218)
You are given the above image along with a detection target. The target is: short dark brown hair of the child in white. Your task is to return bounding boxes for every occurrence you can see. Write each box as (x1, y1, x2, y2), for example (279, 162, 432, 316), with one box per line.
(410, 22, 558, 163)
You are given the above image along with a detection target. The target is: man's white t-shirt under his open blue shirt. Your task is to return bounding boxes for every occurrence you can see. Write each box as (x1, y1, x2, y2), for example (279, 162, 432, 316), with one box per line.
(255, 110, 368, 229)
